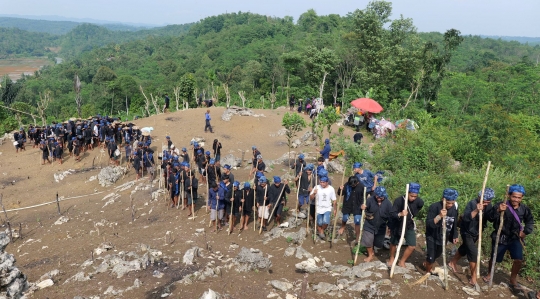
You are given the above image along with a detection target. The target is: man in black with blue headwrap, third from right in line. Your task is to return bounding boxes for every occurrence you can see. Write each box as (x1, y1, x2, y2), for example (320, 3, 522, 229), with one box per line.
(423, 188, 459, 273)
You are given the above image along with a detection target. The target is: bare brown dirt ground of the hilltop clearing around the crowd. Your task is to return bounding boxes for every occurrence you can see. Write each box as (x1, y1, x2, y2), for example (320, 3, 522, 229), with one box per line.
(0, 107, 532, 299)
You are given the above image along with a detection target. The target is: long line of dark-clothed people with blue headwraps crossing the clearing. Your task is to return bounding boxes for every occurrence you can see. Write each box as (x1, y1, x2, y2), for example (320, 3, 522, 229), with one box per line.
(9, 111, 534, 290)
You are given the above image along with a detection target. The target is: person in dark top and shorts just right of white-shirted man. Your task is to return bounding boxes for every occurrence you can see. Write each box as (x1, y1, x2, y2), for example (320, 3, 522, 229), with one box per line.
(338, 175, 365, 239)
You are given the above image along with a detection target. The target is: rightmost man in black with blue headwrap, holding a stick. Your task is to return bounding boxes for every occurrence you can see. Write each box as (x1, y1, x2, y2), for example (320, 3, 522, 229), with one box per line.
(483, 185, 534, 291)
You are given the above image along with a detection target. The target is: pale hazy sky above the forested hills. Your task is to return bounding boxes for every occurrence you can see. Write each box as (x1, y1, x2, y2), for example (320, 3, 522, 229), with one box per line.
(0, 0, 540, 37)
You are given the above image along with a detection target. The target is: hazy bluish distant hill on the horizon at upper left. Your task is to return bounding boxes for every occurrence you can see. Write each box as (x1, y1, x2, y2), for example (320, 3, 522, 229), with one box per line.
(0, 17, 147, 35)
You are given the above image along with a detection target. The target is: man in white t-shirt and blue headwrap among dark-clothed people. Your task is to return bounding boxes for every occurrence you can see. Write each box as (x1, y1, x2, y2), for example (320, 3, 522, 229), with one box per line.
(309, 176, 337, 240)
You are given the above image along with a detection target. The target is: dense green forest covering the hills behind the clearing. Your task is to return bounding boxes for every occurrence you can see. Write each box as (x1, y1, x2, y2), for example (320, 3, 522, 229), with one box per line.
(0, 1, 540, 279)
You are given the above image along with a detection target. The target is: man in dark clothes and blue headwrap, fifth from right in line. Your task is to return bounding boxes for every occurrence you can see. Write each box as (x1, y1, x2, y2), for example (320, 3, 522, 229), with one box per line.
(360, 186, 392, 262)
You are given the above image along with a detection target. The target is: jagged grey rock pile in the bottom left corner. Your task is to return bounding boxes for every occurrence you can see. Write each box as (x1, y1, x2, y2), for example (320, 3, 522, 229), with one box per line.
(0, 232, 28, 298)
